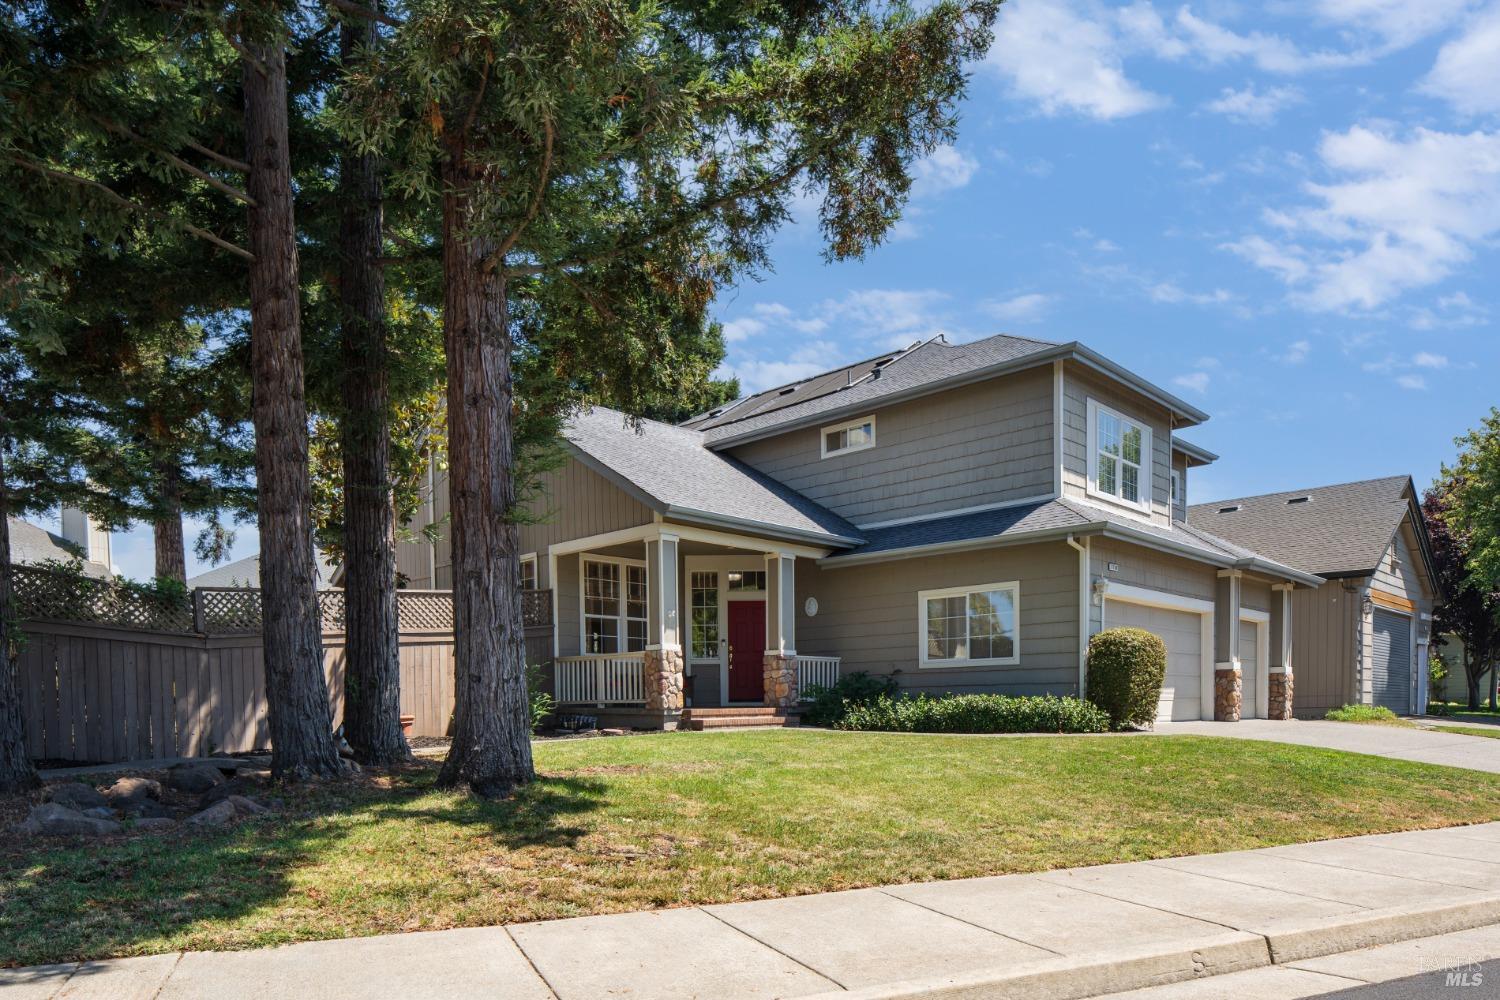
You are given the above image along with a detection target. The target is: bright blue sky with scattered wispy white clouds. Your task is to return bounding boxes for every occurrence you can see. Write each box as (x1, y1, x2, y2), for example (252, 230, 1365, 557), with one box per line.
(85, 0, 1500, 576)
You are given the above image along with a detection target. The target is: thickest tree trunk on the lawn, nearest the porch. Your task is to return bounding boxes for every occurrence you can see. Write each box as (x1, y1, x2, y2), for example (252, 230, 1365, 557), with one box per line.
(438, 162, 536, 798)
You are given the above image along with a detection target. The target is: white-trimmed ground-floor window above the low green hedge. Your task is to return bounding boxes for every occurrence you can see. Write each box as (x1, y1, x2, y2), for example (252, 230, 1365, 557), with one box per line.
(917, 582, 1020, 667)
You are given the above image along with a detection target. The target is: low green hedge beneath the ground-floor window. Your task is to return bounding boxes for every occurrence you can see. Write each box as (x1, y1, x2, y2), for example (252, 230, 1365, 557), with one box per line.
(839, 694, 1110, 733)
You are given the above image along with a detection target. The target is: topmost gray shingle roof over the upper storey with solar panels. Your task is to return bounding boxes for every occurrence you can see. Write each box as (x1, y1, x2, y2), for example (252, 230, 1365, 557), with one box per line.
(683, 334, 1208, 448)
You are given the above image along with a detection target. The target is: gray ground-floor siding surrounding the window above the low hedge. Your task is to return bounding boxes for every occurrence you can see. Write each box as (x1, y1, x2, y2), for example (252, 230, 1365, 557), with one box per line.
(797, 543, 1079, 694)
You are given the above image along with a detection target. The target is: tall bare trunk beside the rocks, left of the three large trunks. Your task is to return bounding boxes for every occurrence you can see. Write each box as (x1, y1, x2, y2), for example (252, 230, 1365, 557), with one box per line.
(243, 39, 344, 780)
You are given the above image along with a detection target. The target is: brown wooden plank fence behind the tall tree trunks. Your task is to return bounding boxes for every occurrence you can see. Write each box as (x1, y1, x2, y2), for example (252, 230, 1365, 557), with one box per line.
(8, 566, 552, 762)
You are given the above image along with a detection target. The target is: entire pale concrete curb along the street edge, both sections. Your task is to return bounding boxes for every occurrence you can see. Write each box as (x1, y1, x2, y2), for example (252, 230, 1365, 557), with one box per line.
(804, 895, 1500, 1000)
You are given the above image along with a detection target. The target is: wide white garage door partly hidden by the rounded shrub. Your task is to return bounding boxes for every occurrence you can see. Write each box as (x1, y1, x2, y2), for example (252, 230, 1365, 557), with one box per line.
(1104, 585, 1214, 723)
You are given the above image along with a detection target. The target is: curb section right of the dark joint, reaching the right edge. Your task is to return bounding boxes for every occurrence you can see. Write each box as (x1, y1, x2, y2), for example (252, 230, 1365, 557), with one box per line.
(1265, 897, 1500, 966)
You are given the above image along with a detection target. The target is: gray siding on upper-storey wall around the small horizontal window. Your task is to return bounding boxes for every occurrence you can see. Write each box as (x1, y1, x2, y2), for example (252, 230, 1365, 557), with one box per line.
(731, 369, 1053, 525)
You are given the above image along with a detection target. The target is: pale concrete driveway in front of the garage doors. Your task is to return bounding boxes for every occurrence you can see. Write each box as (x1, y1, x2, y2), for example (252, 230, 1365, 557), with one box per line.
(1155, 718, 1500, 774)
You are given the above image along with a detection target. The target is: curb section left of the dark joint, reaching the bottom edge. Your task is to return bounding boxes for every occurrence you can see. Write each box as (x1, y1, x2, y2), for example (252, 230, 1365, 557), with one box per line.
(803, 931, 1271, 1000)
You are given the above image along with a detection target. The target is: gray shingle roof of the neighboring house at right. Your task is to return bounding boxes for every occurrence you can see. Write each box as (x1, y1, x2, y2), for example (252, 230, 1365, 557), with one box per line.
(1188, 475, 1431, 577)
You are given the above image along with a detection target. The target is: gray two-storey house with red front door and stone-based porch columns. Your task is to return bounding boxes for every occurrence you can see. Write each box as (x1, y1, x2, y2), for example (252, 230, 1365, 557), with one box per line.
(401, 336, 1323, 727)
